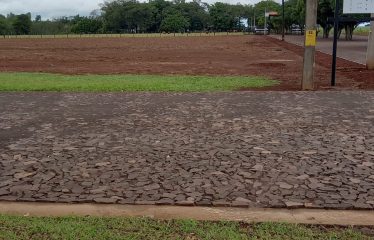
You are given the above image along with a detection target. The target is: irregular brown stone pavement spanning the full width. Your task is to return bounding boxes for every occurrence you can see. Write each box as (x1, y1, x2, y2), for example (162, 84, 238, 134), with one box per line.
(0, 91, 374, 209)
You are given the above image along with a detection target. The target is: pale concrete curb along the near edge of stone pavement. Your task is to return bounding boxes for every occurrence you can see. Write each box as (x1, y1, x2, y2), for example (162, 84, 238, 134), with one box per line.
(0, 202, 374, 226)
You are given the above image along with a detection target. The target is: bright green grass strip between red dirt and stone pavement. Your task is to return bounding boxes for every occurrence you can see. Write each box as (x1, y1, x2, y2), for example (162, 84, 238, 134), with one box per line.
(0, 73, 277, 92)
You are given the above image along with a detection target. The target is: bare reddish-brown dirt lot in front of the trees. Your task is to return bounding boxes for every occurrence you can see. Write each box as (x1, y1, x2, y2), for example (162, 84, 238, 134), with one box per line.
(0, 36, 374, 90)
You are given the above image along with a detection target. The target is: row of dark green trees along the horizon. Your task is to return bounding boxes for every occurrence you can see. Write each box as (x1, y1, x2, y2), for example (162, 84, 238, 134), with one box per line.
(0, 0, 363, 37)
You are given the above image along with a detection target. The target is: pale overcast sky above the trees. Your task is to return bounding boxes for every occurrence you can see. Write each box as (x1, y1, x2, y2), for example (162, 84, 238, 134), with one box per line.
(0, 0, 280, 19)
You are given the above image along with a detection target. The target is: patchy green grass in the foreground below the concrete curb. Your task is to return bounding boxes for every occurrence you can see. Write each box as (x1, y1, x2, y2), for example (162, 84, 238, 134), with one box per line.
(0, 215, 372, 240)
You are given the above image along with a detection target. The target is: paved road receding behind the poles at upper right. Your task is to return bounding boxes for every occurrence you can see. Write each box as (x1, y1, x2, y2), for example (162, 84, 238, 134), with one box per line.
(273, 35, 368, 65)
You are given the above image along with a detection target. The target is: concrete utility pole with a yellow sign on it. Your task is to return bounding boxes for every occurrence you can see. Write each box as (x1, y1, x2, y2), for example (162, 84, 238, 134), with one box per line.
(301, 0, 318, 90)
